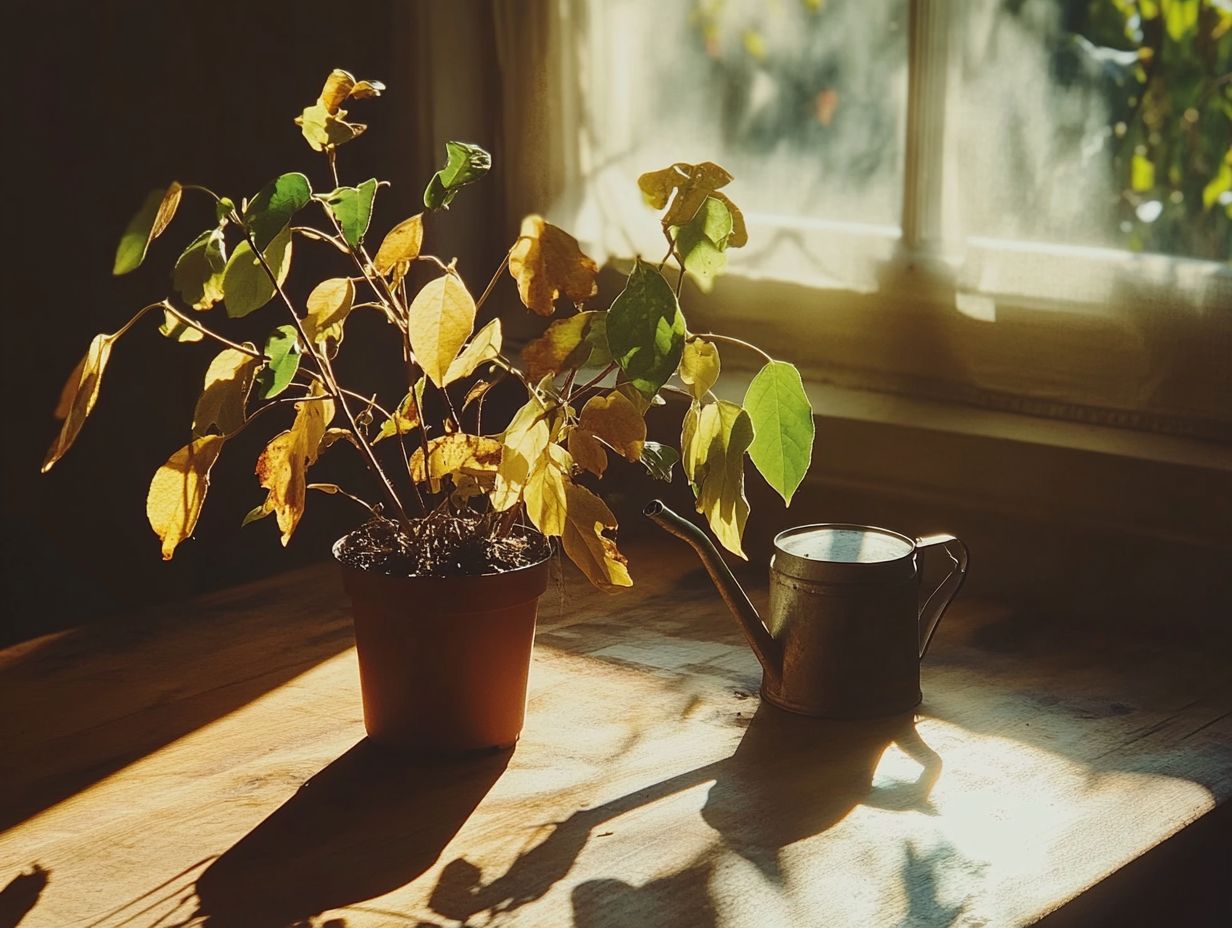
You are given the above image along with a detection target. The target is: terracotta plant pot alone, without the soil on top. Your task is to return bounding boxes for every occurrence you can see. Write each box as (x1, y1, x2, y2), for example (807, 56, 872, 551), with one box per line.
(334, 540, 549, 754)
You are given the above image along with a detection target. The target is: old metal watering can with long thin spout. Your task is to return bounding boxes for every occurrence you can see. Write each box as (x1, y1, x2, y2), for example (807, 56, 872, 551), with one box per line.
(644, 499, 967, 718)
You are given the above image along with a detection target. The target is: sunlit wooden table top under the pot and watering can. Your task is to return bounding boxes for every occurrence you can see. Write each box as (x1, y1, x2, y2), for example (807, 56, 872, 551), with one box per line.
(0, 540, 1232, 928)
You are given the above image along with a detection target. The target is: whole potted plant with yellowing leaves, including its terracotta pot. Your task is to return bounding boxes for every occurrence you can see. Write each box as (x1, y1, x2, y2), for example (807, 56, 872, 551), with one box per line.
(43, 70, 813, 751)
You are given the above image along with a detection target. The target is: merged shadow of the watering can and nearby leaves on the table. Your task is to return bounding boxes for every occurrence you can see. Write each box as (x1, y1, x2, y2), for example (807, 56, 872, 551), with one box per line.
(430, 704, 941, 928)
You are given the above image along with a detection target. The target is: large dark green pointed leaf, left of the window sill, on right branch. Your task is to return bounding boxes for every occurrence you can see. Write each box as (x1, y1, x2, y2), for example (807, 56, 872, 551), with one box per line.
(607, 259, 685, 396)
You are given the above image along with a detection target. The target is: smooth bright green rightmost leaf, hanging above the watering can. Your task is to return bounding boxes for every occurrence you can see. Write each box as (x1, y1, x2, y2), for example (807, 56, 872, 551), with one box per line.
(744, 361, 814, 505)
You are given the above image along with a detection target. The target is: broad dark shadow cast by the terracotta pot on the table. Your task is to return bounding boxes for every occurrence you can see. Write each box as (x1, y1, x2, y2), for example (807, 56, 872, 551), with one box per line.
(193, 739, 513, 928)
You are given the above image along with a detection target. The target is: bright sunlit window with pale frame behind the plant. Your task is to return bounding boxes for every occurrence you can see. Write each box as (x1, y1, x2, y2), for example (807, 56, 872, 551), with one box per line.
(524, 0, 1232, 439)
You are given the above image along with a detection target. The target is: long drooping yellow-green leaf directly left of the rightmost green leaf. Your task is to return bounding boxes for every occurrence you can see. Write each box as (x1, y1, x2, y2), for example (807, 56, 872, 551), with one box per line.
(681, 402, 753, 557)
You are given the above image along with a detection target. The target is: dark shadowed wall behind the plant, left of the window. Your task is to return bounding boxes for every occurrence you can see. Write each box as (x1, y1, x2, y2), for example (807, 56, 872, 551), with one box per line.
(0, 0, 500, 643)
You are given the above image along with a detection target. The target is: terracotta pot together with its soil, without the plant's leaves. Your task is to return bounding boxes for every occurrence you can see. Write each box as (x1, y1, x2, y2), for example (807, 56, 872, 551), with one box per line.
(334, 518, 552, 754)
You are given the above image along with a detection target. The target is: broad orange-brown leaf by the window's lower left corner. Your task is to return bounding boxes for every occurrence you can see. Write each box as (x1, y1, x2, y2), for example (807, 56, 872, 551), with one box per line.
(509, 216, 599, 315)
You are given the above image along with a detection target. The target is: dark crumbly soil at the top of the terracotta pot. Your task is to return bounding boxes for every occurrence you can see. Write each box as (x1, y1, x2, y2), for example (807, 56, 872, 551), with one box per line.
(338, 514, 552, 577)
